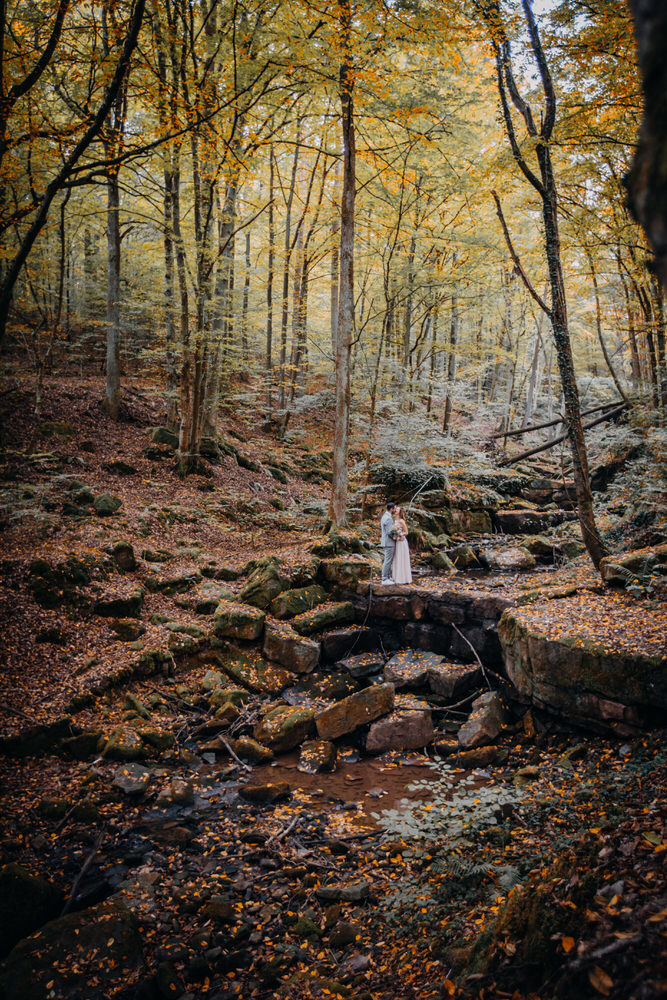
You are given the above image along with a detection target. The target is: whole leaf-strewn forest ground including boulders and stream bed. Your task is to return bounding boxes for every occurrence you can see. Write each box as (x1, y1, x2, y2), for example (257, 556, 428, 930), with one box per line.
(0, 379, 667, 1000)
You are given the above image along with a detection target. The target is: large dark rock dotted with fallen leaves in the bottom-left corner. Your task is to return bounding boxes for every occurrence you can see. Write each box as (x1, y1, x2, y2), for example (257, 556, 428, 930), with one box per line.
(0, 901, 143, 1000)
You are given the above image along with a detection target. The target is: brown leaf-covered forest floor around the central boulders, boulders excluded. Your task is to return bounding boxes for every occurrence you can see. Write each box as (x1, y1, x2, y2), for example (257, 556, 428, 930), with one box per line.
(0, 378, 667, 1000)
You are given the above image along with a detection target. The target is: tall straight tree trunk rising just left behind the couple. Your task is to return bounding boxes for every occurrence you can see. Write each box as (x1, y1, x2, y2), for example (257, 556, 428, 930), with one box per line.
(329, 7, 356, 526)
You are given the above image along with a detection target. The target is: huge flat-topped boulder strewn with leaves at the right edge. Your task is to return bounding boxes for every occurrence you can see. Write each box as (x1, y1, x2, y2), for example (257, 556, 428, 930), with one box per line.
(498, 591, 667, 735)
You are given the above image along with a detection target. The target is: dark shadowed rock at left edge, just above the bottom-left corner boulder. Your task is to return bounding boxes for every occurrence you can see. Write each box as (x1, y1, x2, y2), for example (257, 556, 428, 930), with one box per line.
(0, 864, 67, 958)
